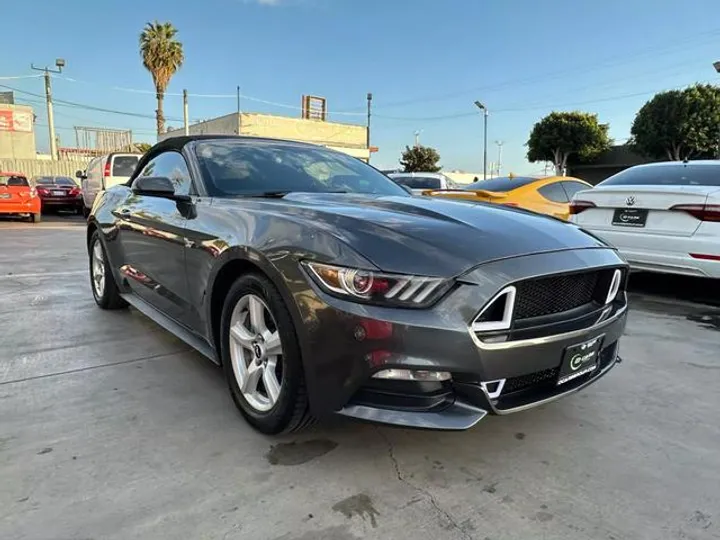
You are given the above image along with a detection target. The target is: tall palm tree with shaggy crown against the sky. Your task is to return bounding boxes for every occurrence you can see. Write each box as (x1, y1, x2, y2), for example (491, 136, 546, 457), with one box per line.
(140, 21, 185, 135)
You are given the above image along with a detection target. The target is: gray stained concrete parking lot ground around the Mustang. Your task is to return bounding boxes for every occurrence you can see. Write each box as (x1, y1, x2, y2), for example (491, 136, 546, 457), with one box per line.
(0, 218, 720, 540)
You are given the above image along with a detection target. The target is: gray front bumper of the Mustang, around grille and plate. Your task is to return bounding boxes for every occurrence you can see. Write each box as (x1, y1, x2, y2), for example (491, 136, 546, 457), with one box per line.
(296, 249, 627, 429)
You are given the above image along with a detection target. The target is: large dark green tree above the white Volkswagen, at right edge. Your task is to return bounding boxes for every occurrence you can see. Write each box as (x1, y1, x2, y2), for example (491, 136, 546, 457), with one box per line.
(630, 84, 720, 161)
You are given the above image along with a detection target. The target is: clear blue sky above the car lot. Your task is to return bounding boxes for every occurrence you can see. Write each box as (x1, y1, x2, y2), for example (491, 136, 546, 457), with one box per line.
(0, 0, 720, 173)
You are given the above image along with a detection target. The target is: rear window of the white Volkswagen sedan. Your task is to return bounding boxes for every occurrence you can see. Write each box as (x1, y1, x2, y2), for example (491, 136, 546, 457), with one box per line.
(598, 164, 720, 186)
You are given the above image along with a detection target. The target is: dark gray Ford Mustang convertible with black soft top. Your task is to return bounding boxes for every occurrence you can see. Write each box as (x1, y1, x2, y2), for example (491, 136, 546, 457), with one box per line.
(87, 136, 628, 434)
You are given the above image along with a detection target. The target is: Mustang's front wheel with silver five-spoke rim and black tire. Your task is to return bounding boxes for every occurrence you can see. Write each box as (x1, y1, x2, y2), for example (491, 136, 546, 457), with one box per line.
(220, 274, 312, 435)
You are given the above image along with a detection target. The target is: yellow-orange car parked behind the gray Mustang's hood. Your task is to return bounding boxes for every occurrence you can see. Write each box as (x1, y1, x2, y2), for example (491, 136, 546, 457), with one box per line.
(423, 175, 592, 221)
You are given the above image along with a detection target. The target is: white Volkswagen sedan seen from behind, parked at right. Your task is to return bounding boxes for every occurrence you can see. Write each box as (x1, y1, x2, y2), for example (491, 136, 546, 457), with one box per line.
(571, 161, 720, 279)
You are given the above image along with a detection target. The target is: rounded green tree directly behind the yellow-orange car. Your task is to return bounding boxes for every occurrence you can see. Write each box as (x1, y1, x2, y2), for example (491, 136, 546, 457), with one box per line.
(527, 111, 612, 175)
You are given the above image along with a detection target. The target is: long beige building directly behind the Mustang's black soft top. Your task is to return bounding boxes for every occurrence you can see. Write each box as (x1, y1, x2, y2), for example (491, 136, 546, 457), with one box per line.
(160, 113, 370, 161)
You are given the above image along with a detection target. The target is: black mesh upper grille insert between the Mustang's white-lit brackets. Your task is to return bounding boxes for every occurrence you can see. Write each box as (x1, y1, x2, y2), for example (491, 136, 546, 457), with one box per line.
(515, 272, 599, 320)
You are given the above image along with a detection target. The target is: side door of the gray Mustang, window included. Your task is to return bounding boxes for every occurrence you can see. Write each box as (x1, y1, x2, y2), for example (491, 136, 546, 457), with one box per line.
(118, 151, 195, 324)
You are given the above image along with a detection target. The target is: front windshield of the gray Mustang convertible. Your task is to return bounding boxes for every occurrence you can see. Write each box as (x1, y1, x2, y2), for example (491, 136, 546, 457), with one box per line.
(195, 139, 409, 197)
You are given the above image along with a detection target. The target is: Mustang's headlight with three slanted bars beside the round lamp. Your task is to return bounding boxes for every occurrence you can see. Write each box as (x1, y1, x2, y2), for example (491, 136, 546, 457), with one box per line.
(302, 261, 452, 308)
